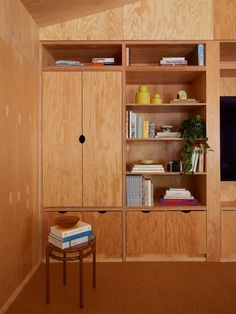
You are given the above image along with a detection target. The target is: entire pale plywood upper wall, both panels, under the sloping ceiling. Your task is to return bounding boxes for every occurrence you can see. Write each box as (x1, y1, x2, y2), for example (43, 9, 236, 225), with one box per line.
(40, 0, 213, 40)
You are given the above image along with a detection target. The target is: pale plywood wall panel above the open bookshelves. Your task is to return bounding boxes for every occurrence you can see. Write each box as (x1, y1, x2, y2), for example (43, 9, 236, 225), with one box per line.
(124, 0, 213, 40)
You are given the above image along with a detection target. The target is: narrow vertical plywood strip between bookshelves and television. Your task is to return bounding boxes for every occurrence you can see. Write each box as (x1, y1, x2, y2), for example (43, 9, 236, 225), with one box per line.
(206, 42, 220, 262)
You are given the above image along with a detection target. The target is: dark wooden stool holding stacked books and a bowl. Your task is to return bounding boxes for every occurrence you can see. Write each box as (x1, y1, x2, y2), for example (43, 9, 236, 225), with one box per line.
(46, 239, 96, 308)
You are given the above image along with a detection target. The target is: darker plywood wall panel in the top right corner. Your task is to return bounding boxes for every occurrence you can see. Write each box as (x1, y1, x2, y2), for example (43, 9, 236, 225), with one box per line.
(214, 0, 236, 40)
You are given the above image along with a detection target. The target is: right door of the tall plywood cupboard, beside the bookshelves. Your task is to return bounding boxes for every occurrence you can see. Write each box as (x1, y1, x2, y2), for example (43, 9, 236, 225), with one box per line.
(83, 72, 122, 206)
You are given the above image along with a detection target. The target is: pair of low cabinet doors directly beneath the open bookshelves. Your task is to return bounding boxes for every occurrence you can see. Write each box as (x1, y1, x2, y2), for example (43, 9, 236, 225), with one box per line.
(126, 211, 206, 260)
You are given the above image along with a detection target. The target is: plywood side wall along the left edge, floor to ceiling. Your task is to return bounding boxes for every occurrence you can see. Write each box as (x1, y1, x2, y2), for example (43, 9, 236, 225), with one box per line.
(0, 0, 41, 312)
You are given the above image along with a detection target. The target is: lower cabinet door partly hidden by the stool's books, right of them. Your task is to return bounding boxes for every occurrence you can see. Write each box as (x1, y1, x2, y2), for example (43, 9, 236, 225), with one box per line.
(83, 211, 122, 261)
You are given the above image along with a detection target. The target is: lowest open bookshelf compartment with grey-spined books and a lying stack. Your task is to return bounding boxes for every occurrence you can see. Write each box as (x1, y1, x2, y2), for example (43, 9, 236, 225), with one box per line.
(126, 172, 206, 208)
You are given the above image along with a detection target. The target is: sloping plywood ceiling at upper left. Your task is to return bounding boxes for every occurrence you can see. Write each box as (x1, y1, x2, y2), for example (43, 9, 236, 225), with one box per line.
(21, 0, 137, 27)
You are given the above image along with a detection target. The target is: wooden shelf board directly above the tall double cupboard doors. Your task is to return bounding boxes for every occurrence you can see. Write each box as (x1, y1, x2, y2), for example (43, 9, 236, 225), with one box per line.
(42, 64, 123, 72)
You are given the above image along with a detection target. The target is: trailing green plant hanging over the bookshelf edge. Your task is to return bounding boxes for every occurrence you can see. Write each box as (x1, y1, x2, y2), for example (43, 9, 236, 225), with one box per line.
(179, 115, 210, 173)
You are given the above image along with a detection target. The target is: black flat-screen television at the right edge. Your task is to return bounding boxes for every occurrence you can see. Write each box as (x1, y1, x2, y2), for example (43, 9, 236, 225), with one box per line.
(220, 96, 236, 181)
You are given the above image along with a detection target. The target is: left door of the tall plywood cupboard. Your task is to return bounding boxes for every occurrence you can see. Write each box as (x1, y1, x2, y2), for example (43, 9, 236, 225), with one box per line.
(43, 72, 82, 207)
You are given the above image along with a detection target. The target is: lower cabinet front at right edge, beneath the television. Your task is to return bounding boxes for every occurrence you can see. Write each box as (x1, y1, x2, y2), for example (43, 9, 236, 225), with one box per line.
(221, 211, 236, 261)
